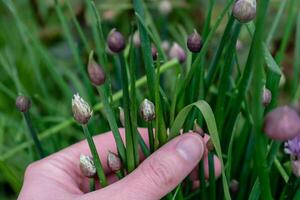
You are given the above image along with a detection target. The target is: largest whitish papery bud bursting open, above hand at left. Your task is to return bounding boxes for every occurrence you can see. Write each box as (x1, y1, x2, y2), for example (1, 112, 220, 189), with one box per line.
(72, 94, 93, 125)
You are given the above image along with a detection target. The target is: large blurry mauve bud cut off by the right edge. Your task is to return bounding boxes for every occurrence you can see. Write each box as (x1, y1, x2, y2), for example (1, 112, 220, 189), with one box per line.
(263, 106, 300, 141)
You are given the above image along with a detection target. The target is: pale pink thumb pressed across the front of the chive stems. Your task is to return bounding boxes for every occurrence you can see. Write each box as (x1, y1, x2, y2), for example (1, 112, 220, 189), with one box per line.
(87, 133, 204, 200)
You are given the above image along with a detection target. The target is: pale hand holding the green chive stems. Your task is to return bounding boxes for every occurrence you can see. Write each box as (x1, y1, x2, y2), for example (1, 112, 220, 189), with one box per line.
(18, 129, 220, 200)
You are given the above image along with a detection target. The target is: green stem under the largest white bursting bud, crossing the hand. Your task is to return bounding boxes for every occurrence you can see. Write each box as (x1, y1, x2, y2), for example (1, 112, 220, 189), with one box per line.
(82, 125, 107, 187)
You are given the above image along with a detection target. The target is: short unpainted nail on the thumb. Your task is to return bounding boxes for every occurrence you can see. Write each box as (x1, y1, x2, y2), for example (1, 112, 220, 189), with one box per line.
(176, 135, 203, 162)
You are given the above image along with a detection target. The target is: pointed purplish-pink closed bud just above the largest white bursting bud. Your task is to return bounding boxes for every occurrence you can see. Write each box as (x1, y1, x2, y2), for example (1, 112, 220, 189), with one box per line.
(88, 59, 106, 86)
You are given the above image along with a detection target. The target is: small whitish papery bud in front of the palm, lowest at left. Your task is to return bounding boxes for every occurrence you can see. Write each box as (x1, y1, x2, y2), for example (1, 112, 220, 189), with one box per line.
(79, 154, 96, 178)
